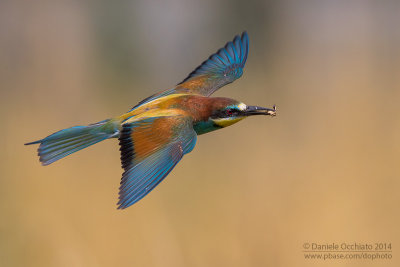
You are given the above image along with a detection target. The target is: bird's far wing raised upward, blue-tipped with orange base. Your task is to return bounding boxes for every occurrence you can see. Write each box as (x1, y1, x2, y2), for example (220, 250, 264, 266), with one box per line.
(175, 32, 249, 96)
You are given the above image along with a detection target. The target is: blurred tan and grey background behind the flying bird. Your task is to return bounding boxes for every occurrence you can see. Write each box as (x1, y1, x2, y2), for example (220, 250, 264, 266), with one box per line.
(0, 0, 400, 266)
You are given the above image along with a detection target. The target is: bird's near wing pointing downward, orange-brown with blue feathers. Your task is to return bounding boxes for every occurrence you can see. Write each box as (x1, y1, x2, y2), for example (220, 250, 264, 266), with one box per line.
(118, 115, 197, 209)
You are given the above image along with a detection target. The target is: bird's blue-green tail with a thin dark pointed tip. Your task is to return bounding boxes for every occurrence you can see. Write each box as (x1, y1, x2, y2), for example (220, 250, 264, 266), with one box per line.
(25, 120, 119, 165)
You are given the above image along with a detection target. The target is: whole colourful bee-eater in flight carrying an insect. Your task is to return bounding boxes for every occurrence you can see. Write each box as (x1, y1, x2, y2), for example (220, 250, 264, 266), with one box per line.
(26, 32, 276, 209)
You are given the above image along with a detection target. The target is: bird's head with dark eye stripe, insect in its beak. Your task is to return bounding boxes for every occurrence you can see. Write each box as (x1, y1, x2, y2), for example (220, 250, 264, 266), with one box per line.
(209, 98, 276, 127)
